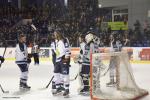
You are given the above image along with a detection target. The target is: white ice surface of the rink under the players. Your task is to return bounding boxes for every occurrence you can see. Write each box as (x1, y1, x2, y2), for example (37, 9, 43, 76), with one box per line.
(0, 61, 150, 100)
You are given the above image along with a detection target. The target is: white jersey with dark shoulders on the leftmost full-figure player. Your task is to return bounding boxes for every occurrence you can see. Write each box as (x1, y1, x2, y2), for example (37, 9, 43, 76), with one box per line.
(15, 43, 28, 64)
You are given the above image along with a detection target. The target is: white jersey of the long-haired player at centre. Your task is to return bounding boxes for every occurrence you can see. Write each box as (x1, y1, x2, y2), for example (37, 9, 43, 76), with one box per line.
(56, 40, 66, 62)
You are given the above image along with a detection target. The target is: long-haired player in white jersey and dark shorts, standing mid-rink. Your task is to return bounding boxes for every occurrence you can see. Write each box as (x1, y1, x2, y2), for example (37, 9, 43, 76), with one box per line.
(53, 31, 70, 97)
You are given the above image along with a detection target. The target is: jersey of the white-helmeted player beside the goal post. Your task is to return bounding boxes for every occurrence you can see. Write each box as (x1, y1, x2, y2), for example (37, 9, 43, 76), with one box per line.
(82, 42, 98, 65)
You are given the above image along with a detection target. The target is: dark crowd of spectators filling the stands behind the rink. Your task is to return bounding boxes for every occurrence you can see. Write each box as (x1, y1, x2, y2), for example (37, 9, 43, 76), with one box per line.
(0, 1, 150, 47)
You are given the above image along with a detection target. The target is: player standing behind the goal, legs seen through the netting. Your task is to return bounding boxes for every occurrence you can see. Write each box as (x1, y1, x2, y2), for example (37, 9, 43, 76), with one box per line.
(106, 34, 122, 86)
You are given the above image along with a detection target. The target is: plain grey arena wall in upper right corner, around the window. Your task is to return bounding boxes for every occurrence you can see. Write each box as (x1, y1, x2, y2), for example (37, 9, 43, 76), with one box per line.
(99, 0, 150, 28)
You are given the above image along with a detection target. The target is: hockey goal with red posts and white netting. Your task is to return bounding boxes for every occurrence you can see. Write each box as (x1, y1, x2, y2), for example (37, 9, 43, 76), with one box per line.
(90, 52, 148, 100)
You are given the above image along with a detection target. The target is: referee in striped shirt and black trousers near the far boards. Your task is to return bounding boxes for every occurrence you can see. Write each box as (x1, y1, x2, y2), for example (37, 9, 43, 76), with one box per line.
(31, 42, 40, 65)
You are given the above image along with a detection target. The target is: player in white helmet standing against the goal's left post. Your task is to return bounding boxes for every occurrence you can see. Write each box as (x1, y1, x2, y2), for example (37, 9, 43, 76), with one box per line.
(80, 32, 97, 94)
